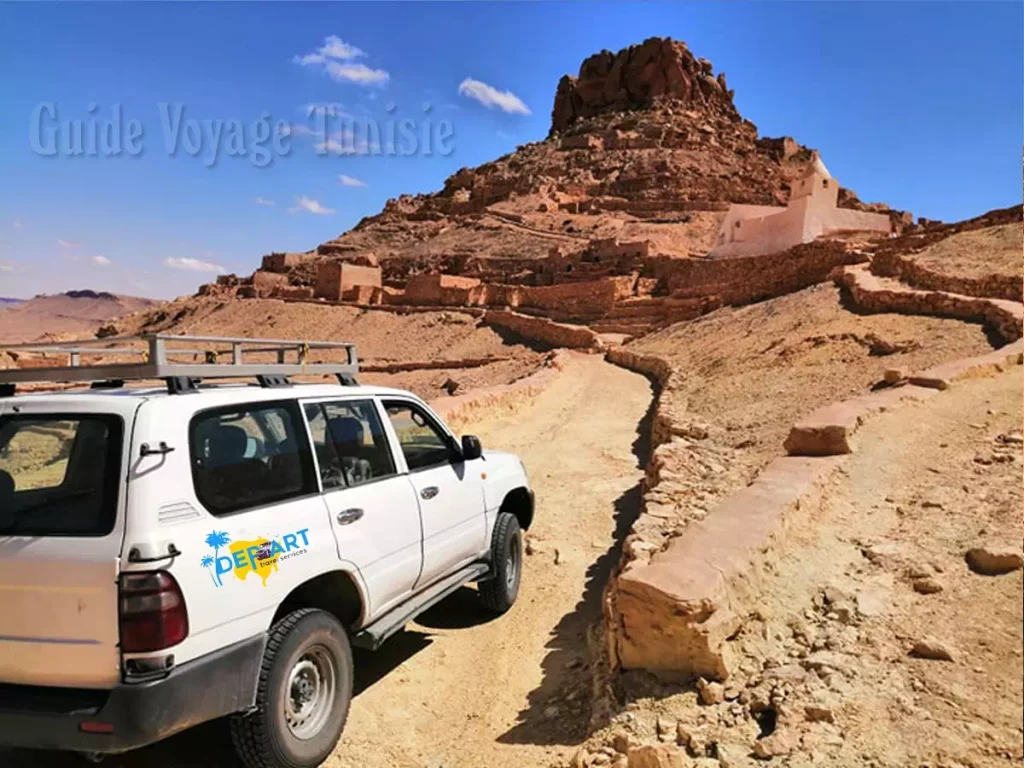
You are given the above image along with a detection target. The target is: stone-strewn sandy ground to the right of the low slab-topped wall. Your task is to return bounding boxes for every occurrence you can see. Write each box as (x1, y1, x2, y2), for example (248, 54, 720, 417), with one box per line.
(588, 369, 1024, 768)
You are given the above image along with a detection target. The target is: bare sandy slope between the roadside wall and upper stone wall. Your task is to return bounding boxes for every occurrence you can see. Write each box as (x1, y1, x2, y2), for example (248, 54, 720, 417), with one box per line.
(629, 284, 1001, 505)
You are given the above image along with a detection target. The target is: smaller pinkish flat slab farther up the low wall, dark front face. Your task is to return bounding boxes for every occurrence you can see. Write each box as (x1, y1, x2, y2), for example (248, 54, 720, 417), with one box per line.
(783, 379, 936, 456)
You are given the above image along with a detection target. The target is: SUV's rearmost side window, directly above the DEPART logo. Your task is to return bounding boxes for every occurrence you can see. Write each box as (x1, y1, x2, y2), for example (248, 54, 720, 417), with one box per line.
(188, 401, 316, 514)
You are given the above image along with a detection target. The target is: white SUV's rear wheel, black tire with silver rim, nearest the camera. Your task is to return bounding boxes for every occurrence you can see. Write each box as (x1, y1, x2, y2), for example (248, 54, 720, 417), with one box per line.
(230, 608, 352, 768)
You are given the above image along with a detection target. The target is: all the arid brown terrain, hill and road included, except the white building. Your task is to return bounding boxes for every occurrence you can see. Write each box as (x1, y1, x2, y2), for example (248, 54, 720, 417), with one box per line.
(0, 38, 1024, 768)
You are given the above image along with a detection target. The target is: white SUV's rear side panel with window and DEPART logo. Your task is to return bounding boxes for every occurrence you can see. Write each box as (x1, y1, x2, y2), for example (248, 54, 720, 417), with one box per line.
(149, 397, 338, 664)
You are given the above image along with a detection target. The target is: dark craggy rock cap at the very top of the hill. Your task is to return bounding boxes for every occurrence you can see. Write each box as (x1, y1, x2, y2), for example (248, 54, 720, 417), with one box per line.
(551, 37, 740, 133)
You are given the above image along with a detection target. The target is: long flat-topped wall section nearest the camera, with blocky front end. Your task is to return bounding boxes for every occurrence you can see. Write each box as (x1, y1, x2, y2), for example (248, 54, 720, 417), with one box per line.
(611, 457, 842, 680)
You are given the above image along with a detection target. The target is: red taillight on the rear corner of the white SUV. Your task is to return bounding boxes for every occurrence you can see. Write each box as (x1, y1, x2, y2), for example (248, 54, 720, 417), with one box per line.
(119, 570, 188, 653)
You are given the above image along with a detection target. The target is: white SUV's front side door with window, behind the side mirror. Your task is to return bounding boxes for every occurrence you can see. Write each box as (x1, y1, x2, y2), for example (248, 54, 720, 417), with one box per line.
(383, 397, 486, 586)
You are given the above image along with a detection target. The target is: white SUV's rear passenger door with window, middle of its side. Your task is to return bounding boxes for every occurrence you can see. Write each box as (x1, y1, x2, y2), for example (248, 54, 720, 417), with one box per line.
(303, 398, 423, 620)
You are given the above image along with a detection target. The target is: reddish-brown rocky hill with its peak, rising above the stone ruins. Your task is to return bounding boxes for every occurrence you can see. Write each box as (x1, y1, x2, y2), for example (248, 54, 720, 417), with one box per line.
(234, 38, 908, 286)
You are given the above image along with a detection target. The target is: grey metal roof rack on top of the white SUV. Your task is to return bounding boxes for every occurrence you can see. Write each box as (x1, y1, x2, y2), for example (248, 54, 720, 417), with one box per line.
(0, 334, 358, 396)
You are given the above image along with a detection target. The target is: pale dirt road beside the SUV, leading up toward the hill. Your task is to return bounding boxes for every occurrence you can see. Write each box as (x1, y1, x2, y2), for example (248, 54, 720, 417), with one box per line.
(6, 355, 652, 768)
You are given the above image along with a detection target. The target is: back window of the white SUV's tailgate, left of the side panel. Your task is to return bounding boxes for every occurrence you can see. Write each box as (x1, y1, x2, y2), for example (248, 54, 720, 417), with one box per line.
(0, 414, 124, 537)
